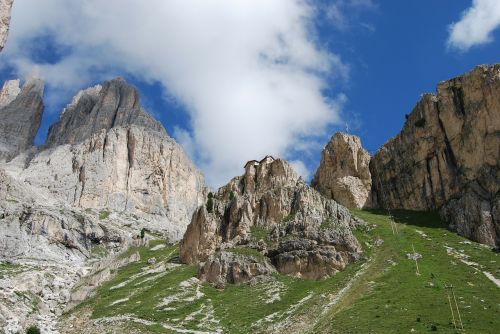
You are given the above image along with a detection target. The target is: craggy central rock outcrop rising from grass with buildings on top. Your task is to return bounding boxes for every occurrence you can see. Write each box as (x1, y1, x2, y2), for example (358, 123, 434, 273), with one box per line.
(180, 156, 362, 282)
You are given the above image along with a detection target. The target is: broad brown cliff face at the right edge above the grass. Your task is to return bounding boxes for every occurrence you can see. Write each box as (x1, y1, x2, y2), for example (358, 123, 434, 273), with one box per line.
(370, 64, 500, 245)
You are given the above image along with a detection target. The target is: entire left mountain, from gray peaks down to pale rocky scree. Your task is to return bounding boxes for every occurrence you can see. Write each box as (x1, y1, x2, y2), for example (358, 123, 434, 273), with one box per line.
(0, 78, 206, 333)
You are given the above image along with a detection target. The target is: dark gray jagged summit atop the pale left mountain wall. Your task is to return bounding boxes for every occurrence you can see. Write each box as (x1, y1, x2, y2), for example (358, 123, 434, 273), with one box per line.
(46, 78, 165, 147)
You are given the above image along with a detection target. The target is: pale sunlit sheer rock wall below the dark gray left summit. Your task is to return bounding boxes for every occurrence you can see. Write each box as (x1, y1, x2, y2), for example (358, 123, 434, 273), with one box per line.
(15, 125, 204, 240)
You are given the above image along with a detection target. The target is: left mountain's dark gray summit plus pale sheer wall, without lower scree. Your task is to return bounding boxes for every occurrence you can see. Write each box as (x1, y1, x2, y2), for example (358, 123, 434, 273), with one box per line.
(0, 79, 204, 240)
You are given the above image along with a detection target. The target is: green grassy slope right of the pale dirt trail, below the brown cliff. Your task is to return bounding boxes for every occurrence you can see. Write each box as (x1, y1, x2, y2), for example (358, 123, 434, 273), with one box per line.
(312, 211, 500, 333)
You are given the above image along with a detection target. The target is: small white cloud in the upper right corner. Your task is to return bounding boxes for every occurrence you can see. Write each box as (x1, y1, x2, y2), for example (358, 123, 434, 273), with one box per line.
(448, 0, 500, 51)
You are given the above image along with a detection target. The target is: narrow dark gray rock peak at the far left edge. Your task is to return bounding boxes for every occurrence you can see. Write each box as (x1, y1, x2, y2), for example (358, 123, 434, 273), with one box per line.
(0, 79, 44, 161)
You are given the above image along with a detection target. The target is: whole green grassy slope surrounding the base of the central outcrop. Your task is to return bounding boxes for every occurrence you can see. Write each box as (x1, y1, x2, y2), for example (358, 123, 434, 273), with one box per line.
(63, 211, 500, 333)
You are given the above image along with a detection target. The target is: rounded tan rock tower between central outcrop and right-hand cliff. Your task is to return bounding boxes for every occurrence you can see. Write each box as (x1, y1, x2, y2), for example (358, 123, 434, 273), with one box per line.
(311, 132, 372, 209)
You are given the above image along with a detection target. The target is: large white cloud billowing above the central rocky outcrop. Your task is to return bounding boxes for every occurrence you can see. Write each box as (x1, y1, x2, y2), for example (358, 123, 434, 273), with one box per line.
(2, 0, 347, 185)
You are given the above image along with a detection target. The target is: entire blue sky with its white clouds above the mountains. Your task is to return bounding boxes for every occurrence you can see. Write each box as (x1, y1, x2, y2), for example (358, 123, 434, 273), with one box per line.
(0, 0, 500, 186)
